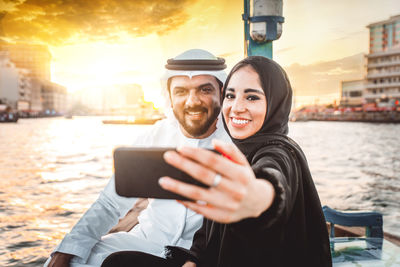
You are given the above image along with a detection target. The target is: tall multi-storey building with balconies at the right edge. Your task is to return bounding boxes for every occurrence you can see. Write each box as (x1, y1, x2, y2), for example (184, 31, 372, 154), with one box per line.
(363, 15, 400, 107)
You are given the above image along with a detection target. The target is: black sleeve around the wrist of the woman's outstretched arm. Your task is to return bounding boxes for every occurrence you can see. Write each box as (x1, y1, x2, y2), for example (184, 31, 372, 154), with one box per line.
(229, 145, 300, 241)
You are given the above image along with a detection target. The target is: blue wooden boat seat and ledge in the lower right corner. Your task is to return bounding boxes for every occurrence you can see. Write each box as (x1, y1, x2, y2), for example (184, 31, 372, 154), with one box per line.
(323, 206, 400, 266)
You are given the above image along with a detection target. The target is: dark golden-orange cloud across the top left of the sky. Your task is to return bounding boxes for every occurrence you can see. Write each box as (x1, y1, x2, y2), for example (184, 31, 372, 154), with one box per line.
(0, 0, 193, 45)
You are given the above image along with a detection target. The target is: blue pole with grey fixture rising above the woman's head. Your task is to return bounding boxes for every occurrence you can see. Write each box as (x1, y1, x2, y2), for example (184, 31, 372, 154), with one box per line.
(242, 0, 285, 59)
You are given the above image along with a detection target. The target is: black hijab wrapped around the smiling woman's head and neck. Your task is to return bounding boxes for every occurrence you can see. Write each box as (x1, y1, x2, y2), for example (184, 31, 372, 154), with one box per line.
(222, 56, 292, 158)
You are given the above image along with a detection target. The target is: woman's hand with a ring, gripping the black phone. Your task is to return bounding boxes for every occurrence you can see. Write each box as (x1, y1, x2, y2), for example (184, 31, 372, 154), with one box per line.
(159, 140, 275, 223)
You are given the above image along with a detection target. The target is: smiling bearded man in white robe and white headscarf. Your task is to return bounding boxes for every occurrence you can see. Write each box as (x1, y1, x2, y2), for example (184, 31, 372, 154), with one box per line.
(45, 49, 230, 267)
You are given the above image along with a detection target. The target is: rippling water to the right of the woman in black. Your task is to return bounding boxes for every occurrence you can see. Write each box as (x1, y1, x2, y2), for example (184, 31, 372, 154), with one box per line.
(290, 122, 400, 235)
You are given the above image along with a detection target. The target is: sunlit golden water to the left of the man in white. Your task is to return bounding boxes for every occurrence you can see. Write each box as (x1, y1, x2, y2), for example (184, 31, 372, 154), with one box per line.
(0, 118, 148, 266)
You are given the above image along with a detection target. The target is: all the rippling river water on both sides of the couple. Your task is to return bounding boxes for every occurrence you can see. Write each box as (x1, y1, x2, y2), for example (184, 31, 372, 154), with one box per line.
(0, 117, 400, 266)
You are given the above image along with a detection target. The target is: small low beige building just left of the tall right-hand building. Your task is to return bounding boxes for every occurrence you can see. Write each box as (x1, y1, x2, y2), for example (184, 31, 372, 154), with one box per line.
(340, 80, 365, 107)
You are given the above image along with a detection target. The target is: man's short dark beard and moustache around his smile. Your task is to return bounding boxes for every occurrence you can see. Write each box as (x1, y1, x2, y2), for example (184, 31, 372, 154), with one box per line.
(173, 106, 221, 137)
